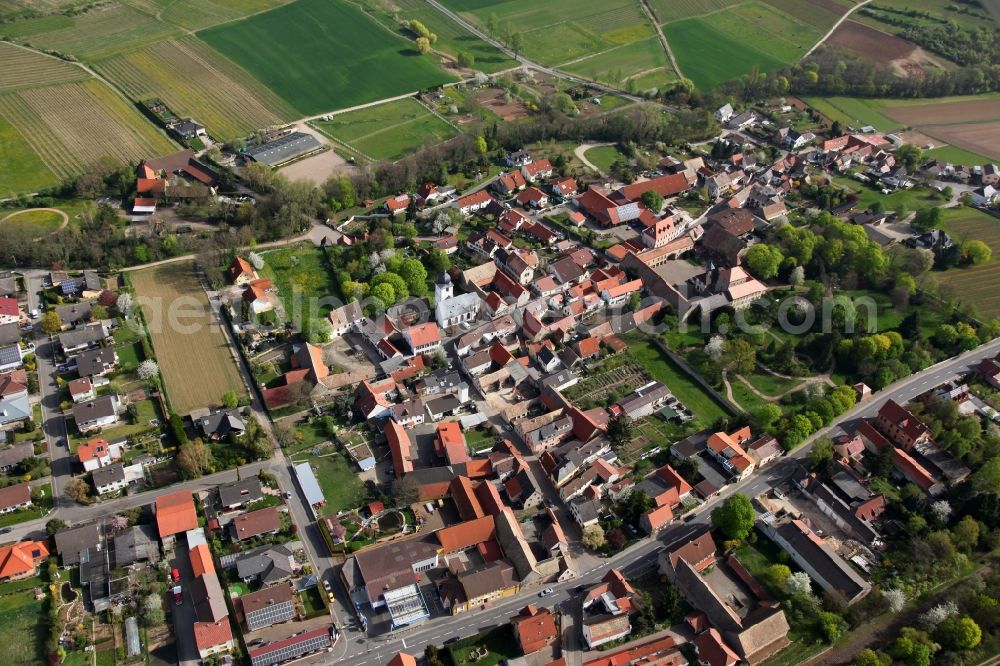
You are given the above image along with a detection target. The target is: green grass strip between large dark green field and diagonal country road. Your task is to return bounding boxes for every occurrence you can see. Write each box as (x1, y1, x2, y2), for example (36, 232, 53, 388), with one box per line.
(362, 0, 515, 74)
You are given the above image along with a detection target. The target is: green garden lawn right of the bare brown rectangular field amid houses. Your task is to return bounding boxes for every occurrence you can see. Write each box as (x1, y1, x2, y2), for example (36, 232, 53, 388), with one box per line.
(262, 245, 338, 318)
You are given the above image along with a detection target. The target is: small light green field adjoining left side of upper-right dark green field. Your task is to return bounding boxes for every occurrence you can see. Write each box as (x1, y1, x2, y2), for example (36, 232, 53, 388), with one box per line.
(562, 37, 676, 91)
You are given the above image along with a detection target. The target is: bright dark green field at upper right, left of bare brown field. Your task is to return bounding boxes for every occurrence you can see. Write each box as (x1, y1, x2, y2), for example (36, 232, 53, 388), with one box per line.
(663, 5, 794, 90)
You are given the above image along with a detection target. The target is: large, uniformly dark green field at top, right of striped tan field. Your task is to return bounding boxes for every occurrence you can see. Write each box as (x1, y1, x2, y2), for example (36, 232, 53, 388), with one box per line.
(198, 0, 452, 113)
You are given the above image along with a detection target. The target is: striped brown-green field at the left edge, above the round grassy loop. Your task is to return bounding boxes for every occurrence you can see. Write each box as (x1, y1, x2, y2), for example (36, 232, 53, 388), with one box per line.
(0, 79, 176, 178)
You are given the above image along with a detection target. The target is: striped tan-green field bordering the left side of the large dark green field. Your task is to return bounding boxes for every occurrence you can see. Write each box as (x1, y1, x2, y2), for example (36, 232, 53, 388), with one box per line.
(95, 37, 297, 141)
